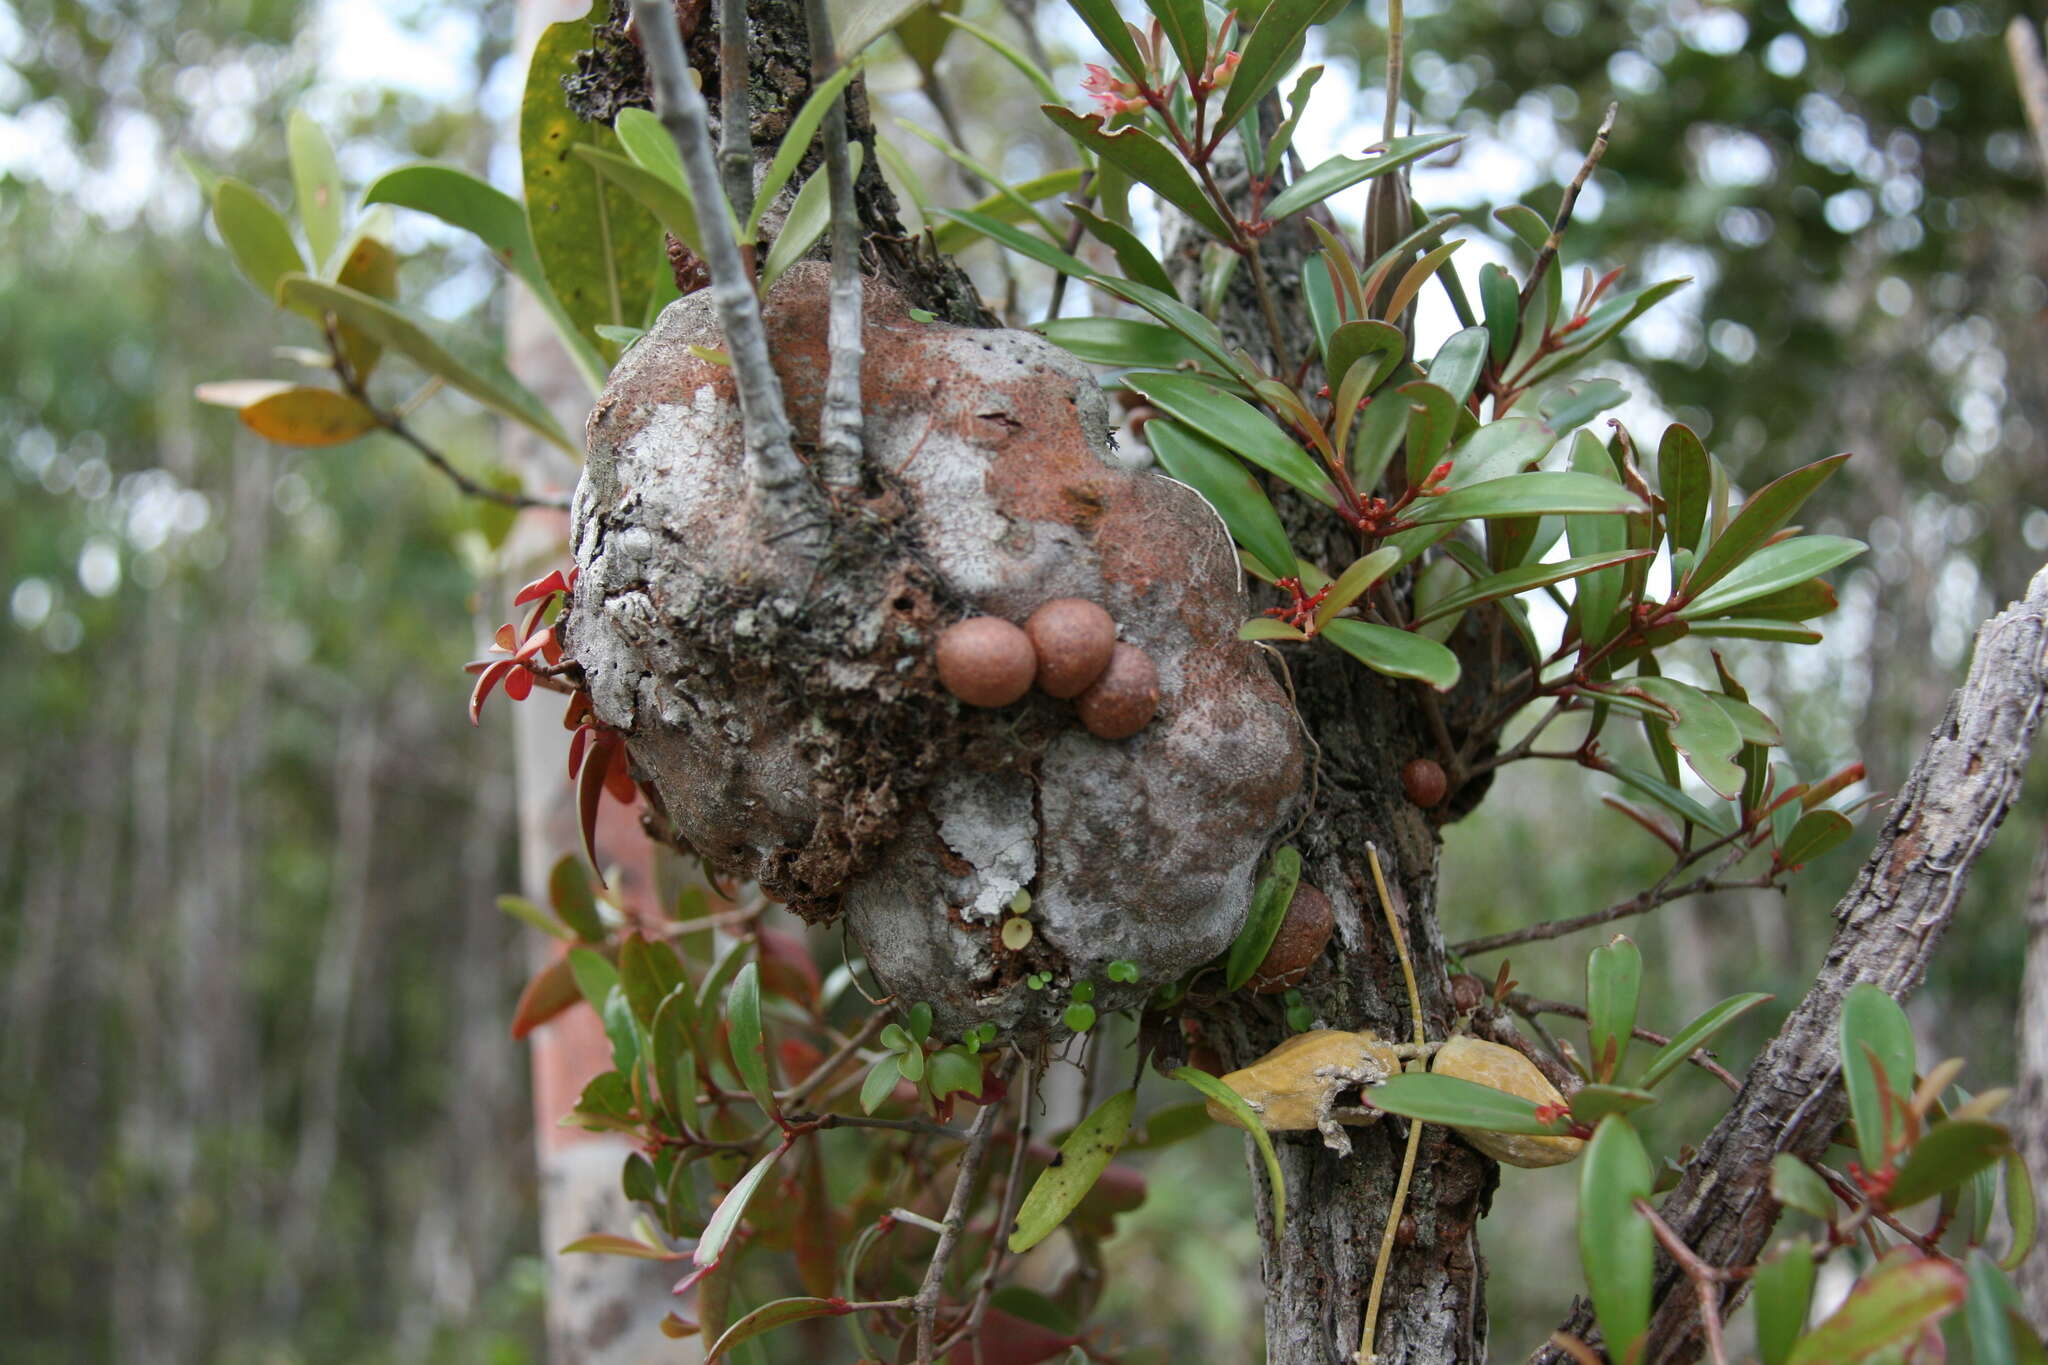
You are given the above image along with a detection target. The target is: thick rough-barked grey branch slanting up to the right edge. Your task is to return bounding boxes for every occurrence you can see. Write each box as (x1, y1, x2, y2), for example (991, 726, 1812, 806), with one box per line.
(1532, 569, 2048, 1365)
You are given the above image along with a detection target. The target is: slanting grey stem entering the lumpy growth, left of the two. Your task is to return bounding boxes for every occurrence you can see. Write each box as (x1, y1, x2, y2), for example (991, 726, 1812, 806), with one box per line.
(633, 0, 823, 548)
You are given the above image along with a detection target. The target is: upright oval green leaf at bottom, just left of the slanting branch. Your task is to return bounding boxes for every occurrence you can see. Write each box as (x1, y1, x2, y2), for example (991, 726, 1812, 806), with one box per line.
(1579, 1113, 1657, 1361)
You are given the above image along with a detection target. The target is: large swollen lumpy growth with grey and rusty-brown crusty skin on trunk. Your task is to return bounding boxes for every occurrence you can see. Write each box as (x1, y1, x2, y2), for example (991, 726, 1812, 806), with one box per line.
(567, 266, 1300, 1031)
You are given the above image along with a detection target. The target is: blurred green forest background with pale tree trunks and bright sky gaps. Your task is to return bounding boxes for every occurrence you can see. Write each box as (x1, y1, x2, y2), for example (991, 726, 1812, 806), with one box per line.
(0, 0, 2048, 1365)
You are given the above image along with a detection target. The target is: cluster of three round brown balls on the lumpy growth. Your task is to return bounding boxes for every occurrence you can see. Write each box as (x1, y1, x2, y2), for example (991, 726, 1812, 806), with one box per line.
(938, 598, 1159, 739)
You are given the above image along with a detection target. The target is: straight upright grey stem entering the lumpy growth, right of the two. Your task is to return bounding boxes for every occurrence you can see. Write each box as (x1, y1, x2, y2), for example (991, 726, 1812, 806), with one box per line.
(803, 0, 862, 489)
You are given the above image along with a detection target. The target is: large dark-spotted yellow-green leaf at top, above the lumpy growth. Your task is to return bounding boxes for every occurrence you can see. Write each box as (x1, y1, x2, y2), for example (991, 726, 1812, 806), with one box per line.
(518, 6, 672, 362)
